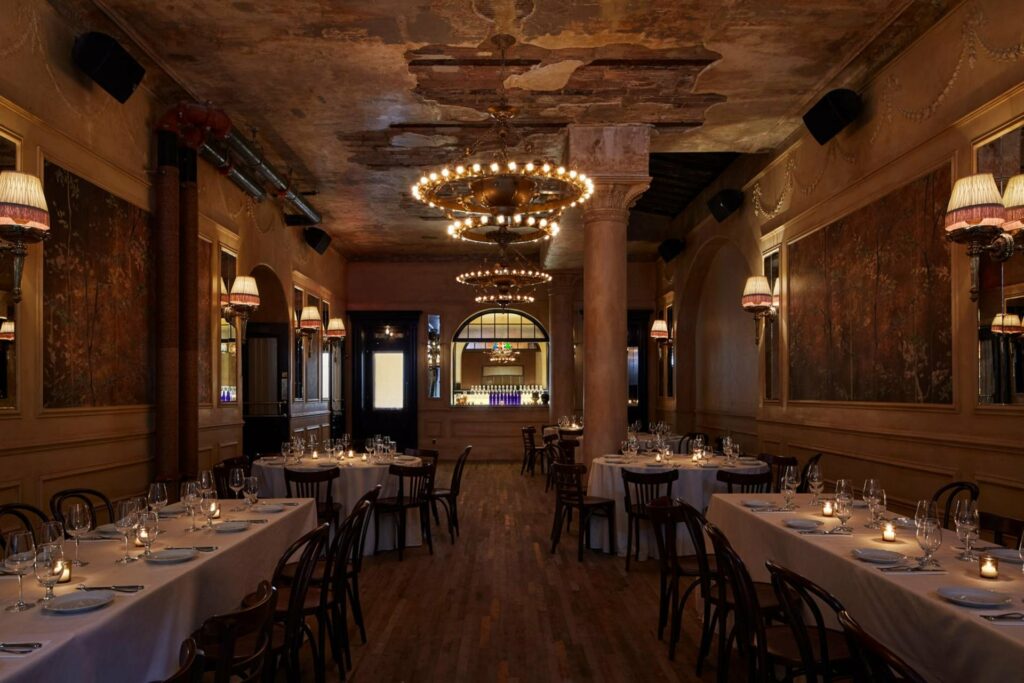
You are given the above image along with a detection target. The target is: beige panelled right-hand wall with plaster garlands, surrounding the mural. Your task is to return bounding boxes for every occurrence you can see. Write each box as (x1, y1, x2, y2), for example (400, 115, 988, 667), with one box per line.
(658, 0, 1024, 517)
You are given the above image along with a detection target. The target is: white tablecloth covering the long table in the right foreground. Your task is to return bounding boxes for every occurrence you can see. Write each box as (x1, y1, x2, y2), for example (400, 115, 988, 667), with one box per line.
(708, 495, 1024, 683)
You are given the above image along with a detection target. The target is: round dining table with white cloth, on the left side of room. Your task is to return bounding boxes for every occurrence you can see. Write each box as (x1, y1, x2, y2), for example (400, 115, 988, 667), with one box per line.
(252, 453, 423, 555)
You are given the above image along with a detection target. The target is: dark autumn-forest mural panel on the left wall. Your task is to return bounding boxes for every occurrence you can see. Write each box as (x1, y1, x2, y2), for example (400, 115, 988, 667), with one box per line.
(43, 161, 155, 408)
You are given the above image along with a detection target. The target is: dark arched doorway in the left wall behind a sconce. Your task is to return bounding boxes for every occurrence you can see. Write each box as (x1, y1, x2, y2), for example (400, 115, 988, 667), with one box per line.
(242, 265, 292, 457)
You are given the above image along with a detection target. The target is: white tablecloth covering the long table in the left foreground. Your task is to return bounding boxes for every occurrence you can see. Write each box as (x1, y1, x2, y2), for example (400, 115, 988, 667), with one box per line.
(0, 499, 316, 683)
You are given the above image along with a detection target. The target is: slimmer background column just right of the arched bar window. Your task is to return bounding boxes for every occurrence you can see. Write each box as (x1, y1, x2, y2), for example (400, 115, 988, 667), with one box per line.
(548, 272, 578, 423)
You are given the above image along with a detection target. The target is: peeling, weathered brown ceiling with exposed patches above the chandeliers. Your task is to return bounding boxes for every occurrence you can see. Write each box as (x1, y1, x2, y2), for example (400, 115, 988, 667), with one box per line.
(83, 0, 952, 259)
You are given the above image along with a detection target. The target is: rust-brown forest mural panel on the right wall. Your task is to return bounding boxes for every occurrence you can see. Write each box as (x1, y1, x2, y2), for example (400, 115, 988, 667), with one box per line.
(786, 166, 952, 403)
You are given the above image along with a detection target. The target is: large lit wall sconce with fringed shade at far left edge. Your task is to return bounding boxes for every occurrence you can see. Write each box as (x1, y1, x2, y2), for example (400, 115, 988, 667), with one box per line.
(0, 171, 50, 303)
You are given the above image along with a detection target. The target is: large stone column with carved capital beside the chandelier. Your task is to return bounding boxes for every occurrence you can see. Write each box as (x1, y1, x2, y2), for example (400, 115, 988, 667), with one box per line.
(568, 125, 650, 466)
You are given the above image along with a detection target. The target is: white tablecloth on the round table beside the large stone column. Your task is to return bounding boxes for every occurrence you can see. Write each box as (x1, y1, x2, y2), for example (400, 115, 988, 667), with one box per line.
(587, 456, 767, 559)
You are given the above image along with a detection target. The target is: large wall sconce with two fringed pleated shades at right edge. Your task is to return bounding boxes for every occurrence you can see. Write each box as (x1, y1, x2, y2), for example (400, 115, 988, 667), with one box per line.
(945, 173, 1024, 301)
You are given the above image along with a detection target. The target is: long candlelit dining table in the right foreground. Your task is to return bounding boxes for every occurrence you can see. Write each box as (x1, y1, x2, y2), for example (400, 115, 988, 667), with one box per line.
(707, 494, 1024, 683)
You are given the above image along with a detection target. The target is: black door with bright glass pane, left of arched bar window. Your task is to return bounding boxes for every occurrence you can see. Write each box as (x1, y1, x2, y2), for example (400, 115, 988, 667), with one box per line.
(349, 311, 420, 451)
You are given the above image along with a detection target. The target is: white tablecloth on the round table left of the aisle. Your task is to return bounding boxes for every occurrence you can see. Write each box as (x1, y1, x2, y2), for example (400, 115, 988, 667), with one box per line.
(253, 458, 423, 555)
